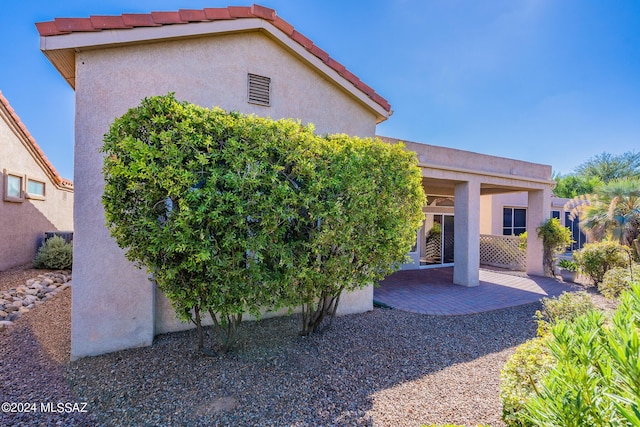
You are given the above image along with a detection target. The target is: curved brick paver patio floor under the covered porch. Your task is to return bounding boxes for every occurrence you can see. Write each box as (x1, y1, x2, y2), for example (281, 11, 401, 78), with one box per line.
(373, 267, 577, 315)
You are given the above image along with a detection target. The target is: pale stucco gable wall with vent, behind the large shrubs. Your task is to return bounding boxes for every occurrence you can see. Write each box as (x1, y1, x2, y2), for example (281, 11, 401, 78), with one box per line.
(72, 32, 376, 358)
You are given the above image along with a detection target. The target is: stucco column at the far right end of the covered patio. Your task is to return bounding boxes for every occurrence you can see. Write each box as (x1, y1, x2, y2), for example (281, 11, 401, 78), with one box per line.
(527, 188, 551, 276)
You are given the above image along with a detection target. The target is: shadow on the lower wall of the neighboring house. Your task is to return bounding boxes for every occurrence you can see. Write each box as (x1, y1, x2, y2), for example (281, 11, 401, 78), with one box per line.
(0, 173, 58, 271)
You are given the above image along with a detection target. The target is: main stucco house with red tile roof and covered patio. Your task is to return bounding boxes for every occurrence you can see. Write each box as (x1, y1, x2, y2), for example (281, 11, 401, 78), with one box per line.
(36, 5, 553, 358)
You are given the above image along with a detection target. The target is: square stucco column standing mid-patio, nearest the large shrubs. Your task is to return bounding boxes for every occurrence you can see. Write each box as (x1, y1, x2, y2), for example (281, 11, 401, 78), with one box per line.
(453, 181, 480, 287)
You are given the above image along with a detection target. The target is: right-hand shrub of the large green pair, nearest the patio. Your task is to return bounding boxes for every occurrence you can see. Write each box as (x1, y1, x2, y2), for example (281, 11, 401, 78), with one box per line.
(292, 135, 426, 334)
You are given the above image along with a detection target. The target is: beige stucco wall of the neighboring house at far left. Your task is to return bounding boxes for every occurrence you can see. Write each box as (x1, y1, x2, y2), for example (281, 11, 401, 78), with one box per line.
(0, 110, 73, 271)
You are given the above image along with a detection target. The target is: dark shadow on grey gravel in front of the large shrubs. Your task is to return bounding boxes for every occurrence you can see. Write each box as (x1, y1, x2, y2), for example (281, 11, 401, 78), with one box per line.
(68, 304, 538, 426)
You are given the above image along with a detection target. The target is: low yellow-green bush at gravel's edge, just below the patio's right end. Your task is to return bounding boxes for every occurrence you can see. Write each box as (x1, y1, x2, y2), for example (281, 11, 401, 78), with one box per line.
(536, 291, 596, 336)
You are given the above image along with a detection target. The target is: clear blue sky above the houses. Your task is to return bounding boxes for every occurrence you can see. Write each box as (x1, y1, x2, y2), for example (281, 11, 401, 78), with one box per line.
(0, 0, 640, 179)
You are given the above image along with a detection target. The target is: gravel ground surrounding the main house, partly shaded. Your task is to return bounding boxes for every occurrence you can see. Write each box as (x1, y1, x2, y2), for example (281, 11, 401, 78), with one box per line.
(0, 270, 600, 427)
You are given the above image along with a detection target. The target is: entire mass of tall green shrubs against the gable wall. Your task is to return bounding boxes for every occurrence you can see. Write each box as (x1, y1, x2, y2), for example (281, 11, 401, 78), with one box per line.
(103, 95, 424, 351)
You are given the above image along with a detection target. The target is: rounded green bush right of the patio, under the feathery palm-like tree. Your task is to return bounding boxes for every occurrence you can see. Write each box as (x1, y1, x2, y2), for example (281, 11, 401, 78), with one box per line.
(573, 241, 631, 285)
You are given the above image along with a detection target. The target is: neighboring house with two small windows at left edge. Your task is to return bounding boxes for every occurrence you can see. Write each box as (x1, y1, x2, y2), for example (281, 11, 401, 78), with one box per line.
(0, 92, 73, 271)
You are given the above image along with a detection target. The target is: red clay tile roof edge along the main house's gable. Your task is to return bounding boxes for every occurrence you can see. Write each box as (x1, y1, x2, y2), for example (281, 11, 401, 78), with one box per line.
(36, 4, 391, 112)
